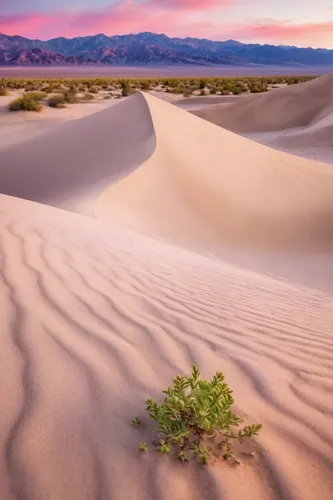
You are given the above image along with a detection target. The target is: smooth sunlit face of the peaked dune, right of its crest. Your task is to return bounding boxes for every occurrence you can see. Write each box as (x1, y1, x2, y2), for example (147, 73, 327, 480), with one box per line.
(96, 95, 333, 249)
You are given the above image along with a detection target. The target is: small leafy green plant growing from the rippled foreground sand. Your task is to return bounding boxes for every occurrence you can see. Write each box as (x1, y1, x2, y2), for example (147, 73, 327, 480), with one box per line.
(132, 365, 261, 464)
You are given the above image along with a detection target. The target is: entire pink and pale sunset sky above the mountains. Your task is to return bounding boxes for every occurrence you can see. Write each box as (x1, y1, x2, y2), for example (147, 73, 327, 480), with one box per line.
(0, 0, 333, 49)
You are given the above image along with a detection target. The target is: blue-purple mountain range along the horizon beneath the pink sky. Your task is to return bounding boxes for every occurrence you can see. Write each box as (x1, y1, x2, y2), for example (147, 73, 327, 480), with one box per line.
(0, 33, 333, 66)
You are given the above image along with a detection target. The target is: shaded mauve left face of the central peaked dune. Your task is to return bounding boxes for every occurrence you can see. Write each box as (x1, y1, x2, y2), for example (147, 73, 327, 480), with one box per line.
(0, 94, 155, 214)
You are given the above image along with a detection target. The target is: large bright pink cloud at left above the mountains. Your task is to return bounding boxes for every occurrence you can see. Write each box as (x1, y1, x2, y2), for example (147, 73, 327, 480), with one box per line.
(0, 0, 231, 39)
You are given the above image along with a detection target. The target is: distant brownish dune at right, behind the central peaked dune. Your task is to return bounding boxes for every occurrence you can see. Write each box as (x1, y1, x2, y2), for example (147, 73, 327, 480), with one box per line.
(189, 73, 333, 163)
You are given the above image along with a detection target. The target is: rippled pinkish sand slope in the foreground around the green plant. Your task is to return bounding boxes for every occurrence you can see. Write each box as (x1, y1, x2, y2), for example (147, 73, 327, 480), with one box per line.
(0, 197, 333, 500)
